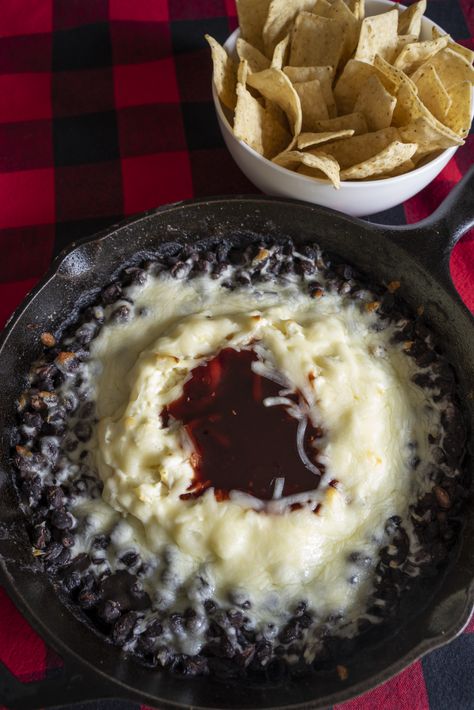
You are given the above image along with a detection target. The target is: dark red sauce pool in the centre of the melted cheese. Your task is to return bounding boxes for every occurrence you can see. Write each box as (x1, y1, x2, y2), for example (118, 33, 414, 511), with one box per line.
(164, 348, 321, 500)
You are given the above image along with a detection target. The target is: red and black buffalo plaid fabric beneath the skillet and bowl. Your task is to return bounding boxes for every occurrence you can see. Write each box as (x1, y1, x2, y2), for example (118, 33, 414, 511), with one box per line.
(0, 0, 474, 710)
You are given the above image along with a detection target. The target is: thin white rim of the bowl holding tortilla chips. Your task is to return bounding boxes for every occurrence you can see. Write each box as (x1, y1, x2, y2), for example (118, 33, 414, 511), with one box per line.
(211, 0, 464, 191)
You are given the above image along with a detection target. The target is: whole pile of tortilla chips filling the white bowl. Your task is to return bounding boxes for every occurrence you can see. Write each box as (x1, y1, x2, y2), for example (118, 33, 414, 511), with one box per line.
(206, 0, 474, 187)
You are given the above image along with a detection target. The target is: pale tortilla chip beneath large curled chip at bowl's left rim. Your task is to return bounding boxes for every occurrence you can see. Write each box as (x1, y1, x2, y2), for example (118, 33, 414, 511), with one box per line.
(234, 83, 291, 159)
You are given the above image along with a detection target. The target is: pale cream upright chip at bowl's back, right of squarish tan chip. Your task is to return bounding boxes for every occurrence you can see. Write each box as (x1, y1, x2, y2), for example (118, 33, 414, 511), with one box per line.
(354, 10, 398, 64)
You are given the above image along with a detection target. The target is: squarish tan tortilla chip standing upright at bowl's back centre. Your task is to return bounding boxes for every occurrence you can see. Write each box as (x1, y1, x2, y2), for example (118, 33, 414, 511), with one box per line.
(290, 12, 344, 68)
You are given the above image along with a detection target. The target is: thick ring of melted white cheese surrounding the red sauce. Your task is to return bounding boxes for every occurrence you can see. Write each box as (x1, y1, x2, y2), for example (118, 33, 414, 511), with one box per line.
(87, 277, 439, 618)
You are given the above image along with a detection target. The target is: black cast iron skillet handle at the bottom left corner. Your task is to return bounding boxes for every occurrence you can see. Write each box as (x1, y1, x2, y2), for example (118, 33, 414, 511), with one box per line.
(0, 661, 115, 710)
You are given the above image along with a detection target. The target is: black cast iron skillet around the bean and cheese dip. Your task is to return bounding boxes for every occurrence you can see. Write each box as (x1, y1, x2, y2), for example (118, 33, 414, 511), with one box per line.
(0, 169, 474, 709)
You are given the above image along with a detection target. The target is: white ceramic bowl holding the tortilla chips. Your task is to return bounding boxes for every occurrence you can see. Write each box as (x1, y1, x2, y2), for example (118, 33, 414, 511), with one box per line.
(212, 0, 466, 217)
